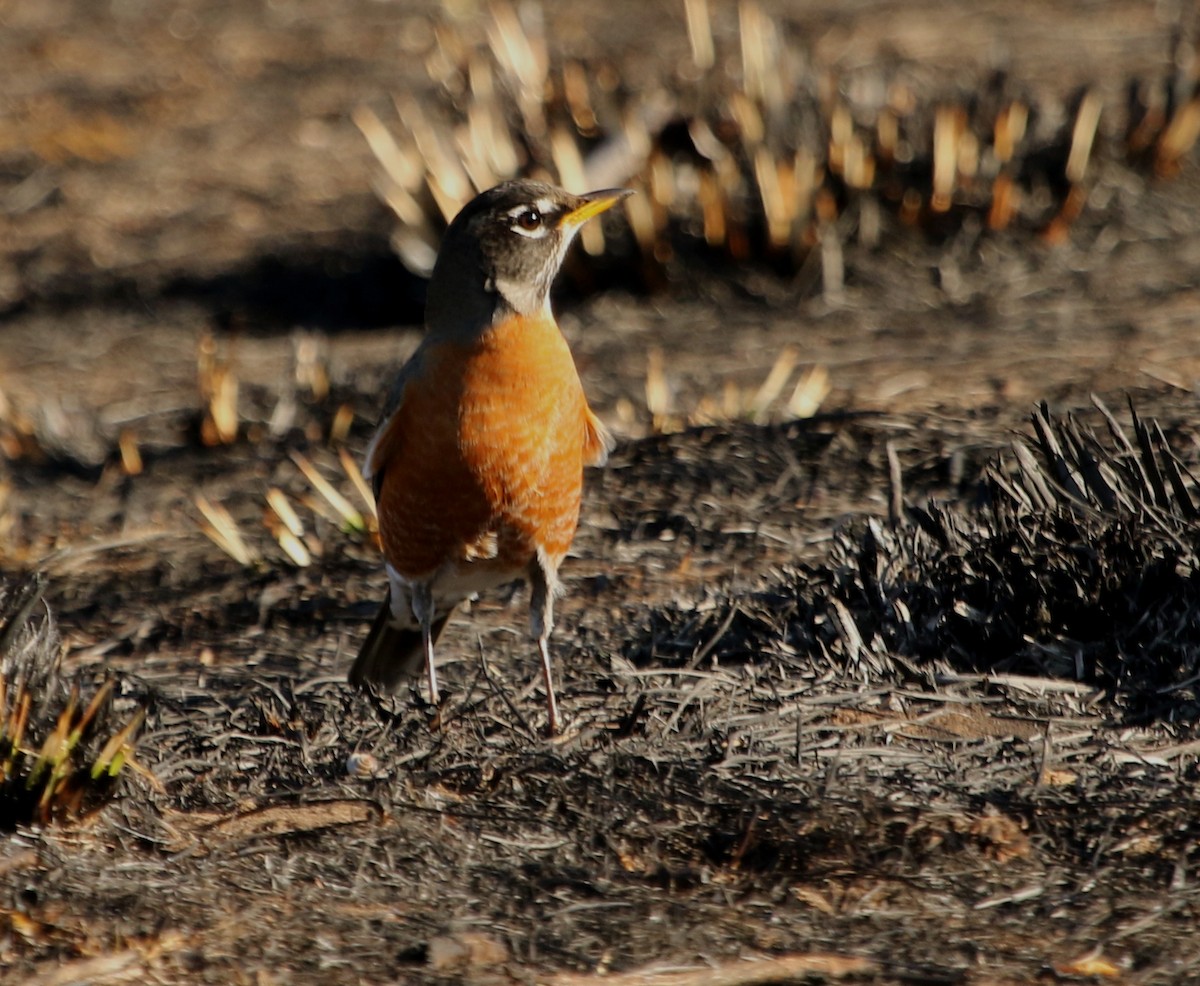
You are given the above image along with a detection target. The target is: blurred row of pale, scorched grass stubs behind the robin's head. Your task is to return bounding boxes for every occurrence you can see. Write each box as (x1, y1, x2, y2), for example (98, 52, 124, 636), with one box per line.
(355, 0, 1200, 299)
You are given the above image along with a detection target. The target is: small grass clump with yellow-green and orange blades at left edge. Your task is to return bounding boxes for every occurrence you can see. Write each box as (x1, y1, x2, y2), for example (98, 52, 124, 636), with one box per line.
(0, 576, 145, 831)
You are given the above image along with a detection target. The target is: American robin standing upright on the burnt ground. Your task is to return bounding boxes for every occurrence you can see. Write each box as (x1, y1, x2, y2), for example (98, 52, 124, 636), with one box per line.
(349, 180, 629, 733)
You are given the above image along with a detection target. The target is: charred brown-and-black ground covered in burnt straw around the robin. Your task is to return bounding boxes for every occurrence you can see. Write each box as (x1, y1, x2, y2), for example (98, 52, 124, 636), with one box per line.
(0, 0, 1200, 984)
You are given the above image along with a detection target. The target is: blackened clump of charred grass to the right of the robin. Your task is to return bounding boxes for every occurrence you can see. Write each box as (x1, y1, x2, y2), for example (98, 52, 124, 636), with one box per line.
(630, 402, 1200, 720)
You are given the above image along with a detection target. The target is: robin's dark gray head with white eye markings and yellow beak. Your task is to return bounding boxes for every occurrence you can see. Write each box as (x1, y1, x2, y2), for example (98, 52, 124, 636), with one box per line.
(426, 179, 630, 331)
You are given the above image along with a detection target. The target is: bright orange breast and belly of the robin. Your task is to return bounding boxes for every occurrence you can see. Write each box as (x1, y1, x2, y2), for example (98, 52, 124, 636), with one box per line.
(379, 319, 590, 581)
